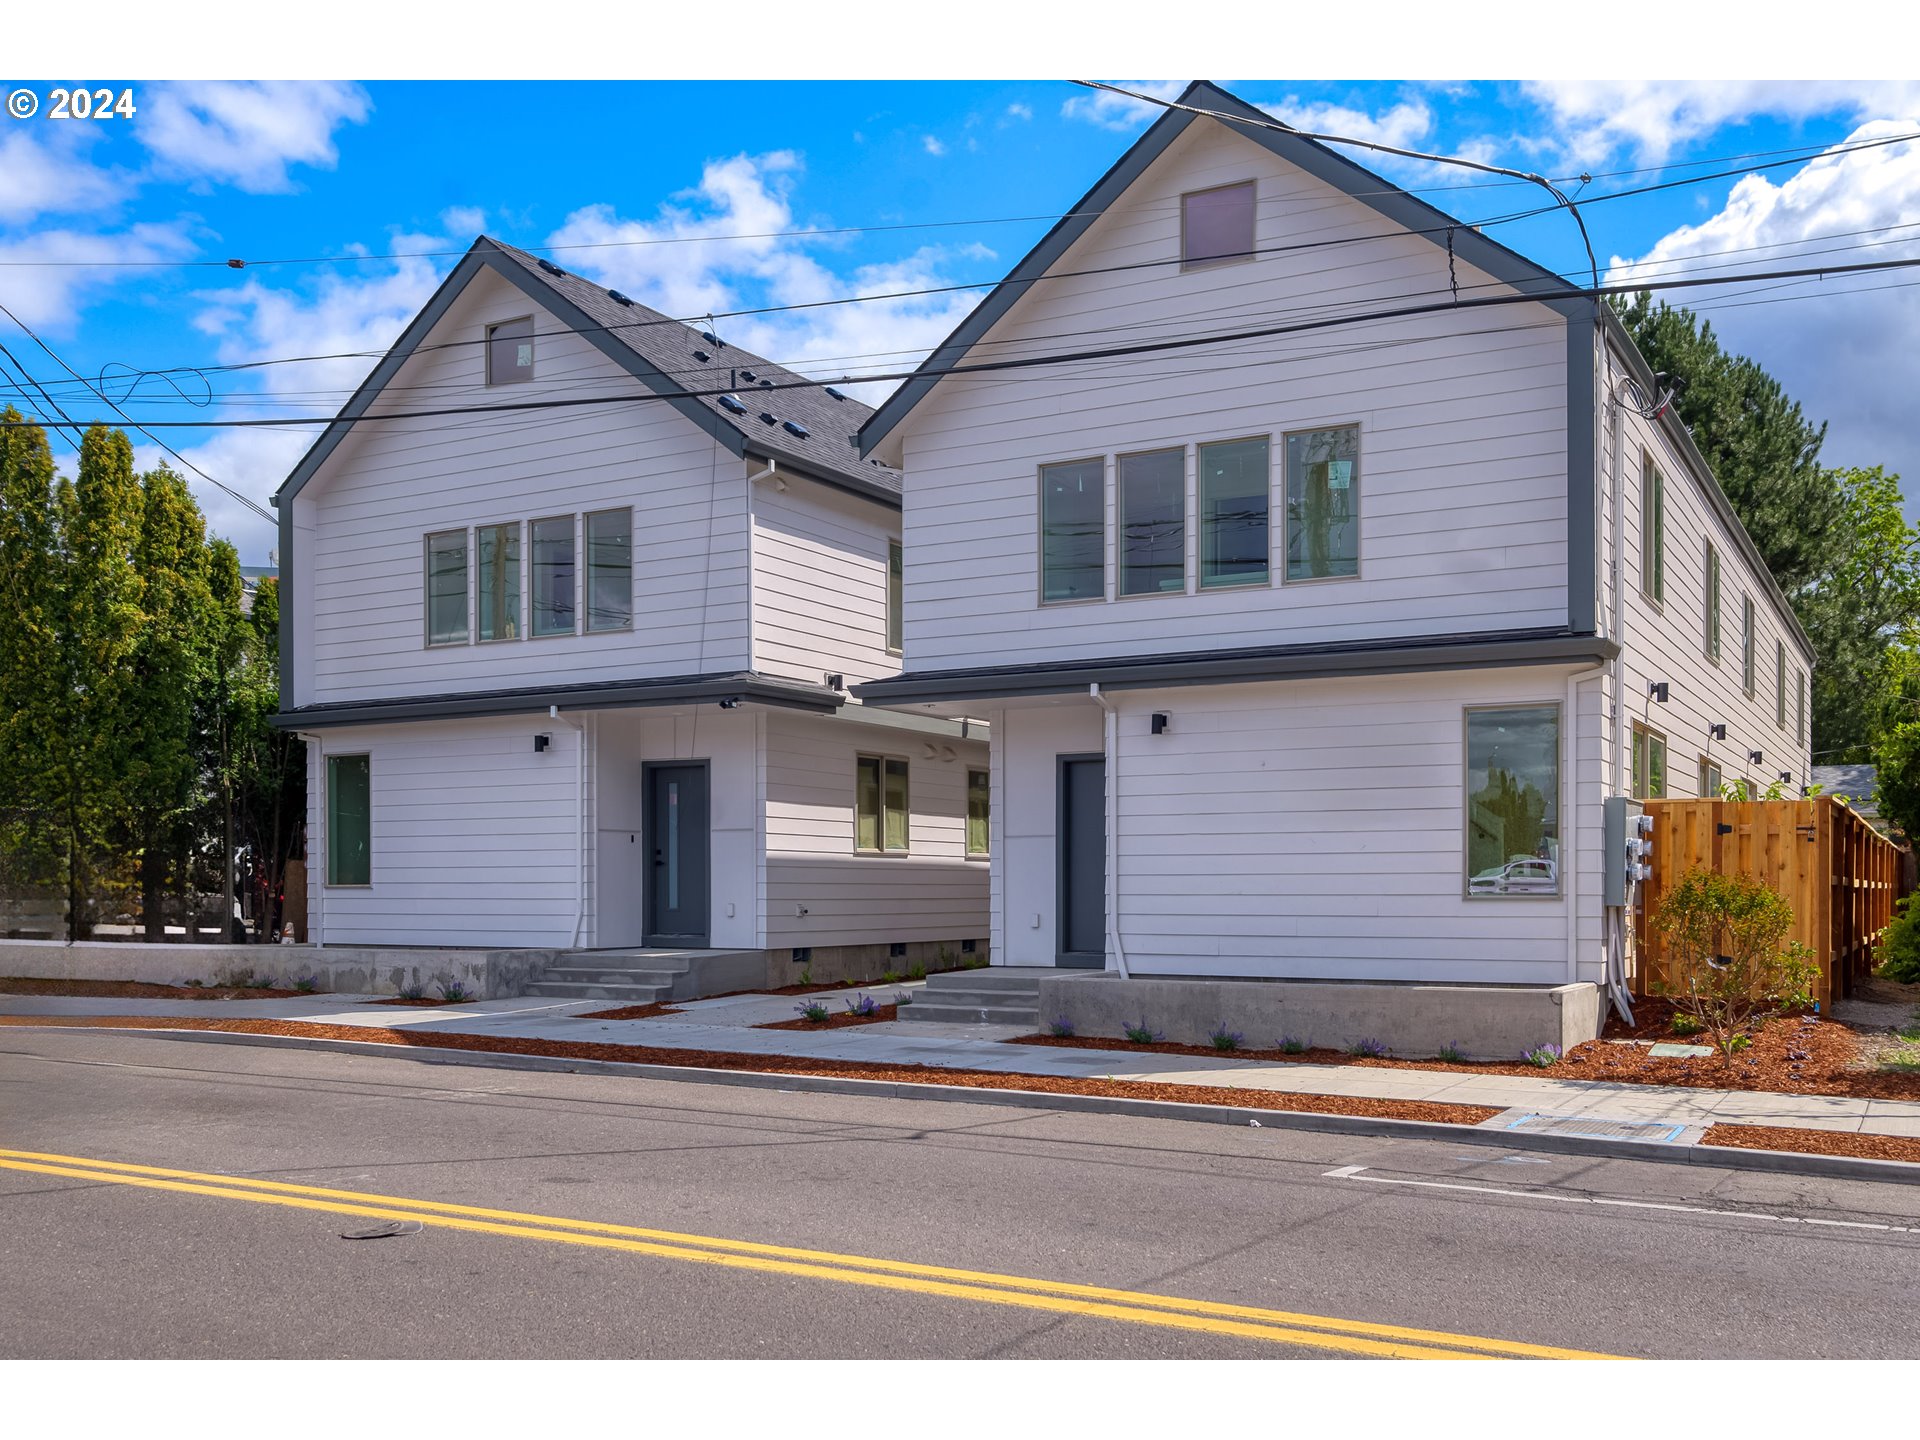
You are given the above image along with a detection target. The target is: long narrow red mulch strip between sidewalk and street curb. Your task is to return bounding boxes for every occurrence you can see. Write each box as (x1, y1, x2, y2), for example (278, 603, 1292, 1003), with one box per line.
(0, 1016, 1500, 1125)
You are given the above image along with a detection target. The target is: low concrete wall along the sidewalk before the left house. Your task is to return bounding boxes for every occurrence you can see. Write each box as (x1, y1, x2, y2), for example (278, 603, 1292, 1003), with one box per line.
(0, 941, 555, 1000)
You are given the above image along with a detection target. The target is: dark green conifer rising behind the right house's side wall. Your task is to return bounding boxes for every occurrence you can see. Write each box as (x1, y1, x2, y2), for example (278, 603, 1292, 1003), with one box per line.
(1615, 290, 1841, 595)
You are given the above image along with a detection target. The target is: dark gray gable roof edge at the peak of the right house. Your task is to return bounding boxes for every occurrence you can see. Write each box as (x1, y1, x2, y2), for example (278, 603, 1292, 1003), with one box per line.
(860, 81, 1592, 455)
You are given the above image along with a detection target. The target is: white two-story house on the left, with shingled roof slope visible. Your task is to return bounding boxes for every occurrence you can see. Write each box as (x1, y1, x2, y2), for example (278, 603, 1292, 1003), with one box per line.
(276, 238, 989, 983)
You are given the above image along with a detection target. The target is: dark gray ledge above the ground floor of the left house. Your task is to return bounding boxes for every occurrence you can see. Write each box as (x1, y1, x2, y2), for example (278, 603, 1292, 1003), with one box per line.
(273, 670, 847, 730)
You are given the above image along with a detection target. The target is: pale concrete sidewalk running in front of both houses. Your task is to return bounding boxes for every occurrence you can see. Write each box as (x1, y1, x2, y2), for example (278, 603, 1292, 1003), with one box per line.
(15, 981, 1920, 1144)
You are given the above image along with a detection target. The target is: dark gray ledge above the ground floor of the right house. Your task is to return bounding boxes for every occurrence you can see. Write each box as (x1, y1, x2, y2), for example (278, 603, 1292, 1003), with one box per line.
(852, 630, 1620, 705)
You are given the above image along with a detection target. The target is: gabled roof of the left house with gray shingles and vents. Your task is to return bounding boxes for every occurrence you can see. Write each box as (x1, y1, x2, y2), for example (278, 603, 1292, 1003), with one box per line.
(275, 236, 900, 507)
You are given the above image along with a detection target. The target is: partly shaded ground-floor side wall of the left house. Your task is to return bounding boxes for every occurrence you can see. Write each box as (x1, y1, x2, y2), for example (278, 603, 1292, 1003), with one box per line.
(764, 714, 989, 950)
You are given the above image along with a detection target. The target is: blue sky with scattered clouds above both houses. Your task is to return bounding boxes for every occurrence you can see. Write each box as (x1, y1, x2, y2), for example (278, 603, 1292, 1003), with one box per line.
(0, 79, 1920, 563)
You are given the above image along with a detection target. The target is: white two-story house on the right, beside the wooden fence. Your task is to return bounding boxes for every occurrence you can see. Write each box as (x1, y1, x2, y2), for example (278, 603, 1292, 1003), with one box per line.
(856, 84, 1812, 1044)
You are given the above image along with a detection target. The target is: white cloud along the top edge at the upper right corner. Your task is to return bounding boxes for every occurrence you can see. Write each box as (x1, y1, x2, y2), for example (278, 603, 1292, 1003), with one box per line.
(1523, 81, 1920, 161)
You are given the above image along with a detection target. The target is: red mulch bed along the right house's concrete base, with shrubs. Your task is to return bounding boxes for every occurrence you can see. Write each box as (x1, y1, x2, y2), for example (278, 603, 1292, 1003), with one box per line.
(1008, 1000, 1920, 1100)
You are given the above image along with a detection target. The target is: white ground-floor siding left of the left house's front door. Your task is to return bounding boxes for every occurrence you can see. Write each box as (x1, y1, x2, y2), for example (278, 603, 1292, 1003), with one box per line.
(307, 716, 582, 948)
